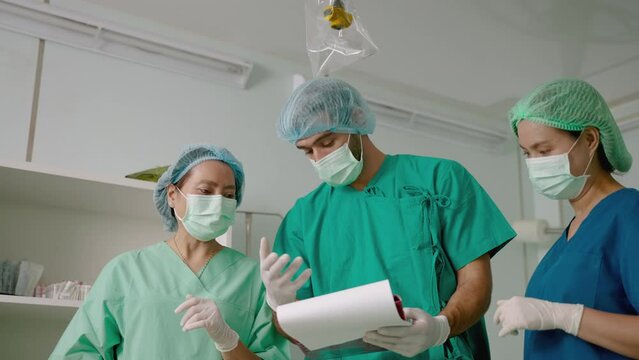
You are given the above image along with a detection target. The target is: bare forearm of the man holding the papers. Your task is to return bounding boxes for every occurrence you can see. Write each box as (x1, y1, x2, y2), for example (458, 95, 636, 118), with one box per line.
(440, 255, 492, 337)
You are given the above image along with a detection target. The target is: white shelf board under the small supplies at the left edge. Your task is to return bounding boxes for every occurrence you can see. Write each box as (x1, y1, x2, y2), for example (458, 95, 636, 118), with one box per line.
(0, 295, 82, 321)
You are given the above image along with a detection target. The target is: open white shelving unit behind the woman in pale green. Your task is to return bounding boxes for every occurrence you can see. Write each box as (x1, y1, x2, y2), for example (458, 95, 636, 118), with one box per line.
(0, 163, 280, 359)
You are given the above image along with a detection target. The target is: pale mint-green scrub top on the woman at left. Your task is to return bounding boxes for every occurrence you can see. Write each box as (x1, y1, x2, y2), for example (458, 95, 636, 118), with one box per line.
(50, 242, 290, 360)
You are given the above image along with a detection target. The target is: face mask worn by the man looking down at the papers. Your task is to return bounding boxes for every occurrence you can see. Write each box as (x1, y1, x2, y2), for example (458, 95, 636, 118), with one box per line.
(311, 135, 364, 187)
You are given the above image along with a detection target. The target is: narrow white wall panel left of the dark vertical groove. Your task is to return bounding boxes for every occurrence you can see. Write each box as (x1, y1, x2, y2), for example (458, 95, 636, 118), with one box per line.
(0, 30, 38, 161)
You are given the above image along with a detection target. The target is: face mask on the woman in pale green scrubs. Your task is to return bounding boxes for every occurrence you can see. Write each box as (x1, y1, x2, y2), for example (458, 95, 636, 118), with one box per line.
(175, 187, 237, 241)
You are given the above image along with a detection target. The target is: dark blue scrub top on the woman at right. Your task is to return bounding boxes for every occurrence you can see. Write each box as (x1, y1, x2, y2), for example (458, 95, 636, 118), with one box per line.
(524, 189, 639, 360)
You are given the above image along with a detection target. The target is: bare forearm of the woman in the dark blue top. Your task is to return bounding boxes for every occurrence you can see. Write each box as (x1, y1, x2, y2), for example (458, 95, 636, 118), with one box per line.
(577, 308, 639, 359)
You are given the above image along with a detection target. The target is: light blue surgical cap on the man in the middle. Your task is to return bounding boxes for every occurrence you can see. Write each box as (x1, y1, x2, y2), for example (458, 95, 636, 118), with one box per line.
(277, 77, 375, 144)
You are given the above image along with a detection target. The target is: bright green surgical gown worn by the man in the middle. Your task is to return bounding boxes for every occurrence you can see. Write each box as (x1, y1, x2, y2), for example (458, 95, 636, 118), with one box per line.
(274, 155, 515, 359)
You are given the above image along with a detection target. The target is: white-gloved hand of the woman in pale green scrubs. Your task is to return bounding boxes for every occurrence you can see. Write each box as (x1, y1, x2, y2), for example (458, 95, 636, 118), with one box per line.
(175, 295, 240, 352)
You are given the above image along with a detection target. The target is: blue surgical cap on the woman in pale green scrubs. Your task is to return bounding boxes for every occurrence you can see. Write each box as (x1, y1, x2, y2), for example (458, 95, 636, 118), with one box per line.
(153, 145, 244, 231)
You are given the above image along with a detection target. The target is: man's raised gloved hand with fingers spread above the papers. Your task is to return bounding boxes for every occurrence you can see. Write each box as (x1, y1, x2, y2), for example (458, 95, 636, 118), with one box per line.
(260, 238, 311, 311)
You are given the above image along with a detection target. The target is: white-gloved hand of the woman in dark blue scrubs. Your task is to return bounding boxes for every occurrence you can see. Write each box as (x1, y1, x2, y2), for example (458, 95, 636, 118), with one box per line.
(494, 296, 584, 336)
